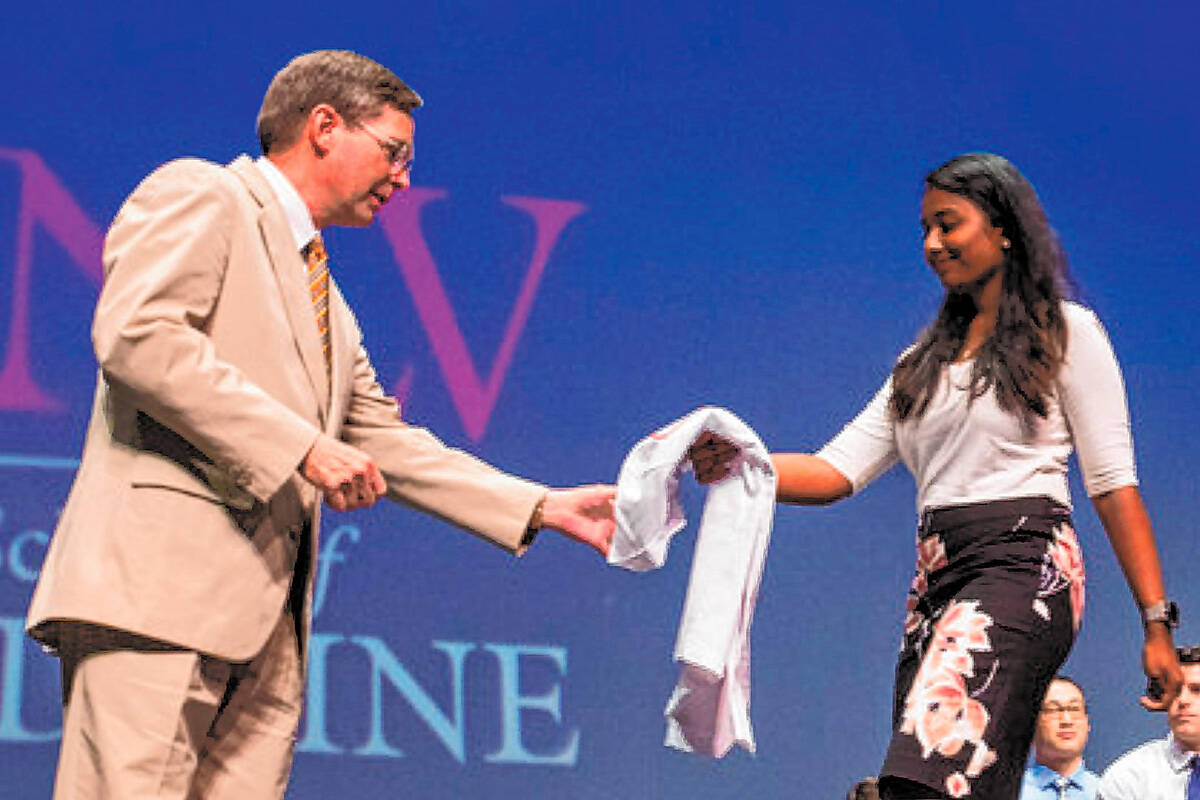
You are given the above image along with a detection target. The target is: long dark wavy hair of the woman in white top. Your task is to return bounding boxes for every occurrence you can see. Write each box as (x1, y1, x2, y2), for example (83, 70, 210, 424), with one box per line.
(892, 152, 1069, 425)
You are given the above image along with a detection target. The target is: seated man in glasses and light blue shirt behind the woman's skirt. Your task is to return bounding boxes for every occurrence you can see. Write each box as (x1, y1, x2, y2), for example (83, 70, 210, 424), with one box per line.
(1020, 675, 1099, 800)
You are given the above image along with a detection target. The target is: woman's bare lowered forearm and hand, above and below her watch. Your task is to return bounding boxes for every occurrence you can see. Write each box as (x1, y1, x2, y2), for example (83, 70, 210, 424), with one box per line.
(1092, 486, 1183, 711)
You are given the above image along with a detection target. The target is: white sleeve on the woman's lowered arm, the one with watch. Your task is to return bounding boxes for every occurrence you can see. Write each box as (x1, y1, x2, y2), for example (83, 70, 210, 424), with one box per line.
(1058, 303, 1138, 497)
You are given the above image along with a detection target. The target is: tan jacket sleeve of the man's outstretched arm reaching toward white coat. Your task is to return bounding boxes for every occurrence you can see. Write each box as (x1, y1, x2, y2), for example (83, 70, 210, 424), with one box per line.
(341, 303, 546, 555)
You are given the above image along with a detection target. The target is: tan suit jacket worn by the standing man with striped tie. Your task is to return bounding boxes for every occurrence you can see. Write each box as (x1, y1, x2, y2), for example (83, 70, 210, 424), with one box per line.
(28, 156, 545, 661)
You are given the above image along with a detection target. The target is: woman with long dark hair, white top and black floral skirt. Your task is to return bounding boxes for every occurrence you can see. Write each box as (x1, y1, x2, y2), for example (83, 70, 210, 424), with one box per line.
(694, 154, 1181, 800)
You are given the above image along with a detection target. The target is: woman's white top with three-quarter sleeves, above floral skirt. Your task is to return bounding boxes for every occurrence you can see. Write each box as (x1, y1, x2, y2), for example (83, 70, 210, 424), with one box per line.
(817, 302, 1138, 513)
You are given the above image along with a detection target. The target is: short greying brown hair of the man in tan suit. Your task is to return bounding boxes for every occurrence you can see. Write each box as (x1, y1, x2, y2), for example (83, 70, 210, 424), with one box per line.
(258, 50, 424, 155)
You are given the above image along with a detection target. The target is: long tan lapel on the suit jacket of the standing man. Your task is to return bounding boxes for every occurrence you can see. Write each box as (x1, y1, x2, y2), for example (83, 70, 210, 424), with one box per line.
(229, 156, 330, 423)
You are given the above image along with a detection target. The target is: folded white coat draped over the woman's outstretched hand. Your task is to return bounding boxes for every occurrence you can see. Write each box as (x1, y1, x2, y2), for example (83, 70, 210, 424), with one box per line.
(608, 407, 775, 758)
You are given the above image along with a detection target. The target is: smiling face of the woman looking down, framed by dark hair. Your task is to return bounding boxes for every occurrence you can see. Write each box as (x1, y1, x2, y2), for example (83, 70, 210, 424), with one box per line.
(920, 187, 1006, 289)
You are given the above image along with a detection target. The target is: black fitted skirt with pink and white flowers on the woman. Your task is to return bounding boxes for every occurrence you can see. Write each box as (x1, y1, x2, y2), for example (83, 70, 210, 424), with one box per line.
(880, 497, 1084, 800)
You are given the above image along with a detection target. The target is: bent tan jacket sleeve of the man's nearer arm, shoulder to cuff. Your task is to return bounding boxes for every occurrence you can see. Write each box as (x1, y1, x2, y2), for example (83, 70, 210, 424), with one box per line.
(92, 160, 318, 501)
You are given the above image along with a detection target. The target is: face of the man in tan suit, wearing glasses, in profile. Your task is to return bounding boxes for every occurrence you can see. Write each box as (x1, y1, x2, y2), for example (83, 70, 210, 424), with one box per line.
(313, 106, 413, 228)
